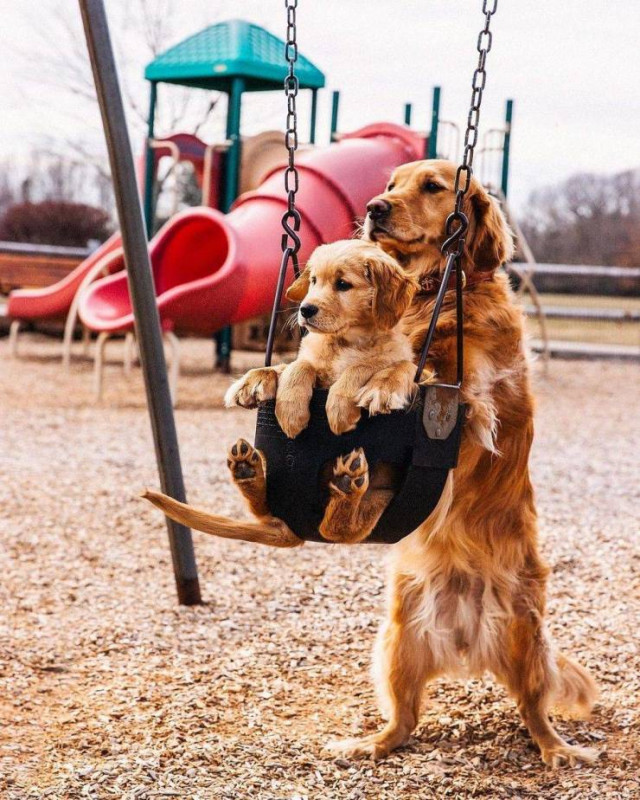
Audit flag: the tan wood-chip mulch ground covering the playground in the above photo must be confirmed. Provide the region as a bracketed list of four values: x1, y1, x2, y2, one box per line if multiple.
[0, 336, 640, 800]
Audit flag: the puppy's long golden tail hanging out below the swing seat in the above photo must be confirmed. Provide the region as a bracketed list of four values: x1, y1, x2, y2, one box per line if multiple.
[140, 489, 303, 547]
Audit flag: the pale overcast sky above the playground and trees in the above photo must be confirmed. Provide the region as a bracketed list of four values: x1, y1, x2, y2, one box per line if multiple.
[0, 0, 640, 207]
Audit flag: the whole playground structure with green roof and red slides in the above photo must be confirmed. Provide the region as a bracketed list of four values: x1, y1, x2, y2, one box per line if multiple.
[8, 20, 520, 398]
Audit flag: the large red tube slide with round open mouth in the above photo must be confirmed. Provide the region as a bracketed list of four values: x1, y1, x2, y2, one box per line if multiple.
[79, 123, 424, 334]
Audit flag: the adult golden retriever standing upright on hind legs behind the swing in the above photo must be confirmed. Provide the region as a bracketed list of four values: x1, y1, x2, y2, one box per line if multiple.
[142, 160, 597, 767]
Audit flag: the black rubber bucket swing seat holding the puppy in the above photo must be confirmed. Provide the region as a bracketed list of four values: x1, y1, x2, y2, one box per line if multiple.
[255, 385, 465, 544]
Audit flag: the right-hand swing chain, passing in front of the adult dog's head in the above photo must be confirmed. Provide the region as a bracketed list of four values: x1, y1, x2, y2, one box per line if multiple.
[442, 0, 498, 256]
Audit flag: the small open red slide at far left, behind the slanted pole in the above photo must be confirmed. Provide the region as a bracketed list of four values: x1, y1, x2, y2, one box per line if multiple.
[7, 233, 122, 320]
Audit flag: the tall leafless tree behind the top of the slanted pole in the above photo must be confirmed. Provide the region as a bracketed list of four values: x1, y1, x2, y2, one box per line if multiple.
[20, 0, 225, 208]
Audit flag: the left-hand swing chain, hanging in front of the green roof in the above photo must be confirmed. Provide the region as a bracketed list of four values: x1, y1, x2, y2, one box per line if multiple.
[282, 0, 301, 278]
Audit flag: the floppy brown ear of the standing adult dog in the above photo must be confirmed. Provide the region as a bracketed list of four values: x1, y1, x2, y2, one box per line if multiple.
[464, 183, 514, 274]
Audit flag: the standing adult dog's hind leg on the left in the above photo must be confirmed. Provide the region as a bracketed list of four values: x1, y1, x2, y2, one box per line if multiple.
[328, 575, 439, 759]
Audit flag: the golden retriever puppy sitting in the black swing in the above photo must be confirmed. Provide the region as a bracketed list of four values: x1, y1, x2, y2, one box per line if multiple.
[144, 240, 418, 547]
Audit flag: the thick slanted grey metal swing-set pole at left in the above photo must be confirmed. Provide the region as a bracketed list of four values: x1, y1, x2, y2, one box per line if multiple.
[79, 0, 201, 605]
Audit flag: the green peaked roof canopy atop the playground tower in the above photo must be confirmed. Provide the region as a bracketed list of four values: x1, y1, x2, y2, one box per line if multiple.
[144, 19, 324, 92]
